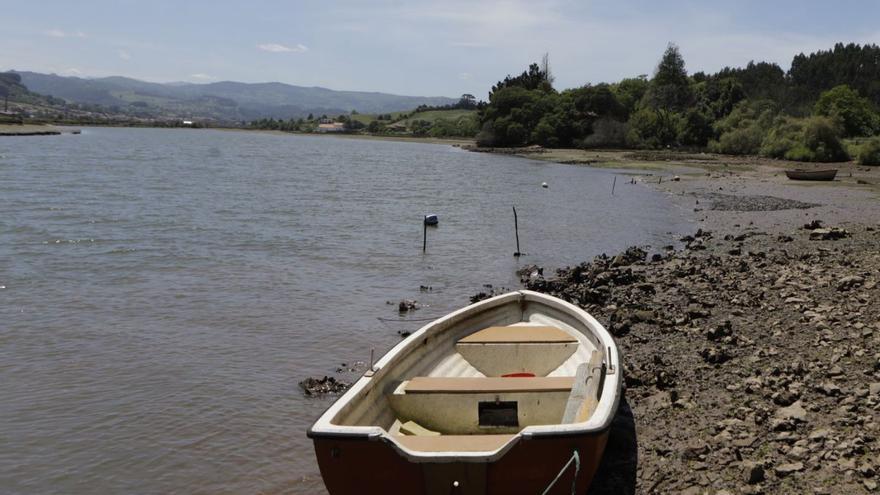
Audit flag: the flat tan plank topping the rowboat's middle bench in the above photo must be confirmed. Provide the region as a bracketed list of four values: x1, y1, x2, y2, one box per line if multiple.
[404, 376, 574, 394]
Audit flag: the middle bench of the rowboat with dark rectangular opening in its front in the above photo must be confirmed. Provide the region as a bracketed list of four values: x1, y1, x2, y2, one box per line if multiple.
[387, 376, 575, 435]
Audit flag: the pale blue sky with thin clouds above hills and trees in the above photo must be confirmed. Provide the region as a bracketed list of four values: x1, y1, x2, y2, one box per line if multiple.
[0, 0, 880, 98]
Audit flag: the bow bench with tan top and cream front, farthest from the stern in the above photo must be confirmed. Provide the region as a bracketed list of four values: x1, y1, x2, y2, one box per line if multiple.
[455, 325, 579, 376]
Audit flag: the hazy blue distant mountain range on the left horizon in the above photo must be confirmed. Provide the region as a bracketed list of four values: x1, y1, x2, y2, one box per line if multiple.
[16, 72, 458, 121]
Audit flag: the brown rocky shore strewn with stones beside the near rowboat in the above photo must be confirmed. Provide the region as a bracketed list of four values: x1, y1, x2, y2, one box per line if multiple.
[523, 223, 880, 494]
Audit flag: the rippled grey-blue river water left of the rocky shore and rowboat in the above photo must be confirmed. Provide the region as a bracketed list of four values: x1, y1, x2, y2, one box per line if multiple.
[0, 129, 690, 494]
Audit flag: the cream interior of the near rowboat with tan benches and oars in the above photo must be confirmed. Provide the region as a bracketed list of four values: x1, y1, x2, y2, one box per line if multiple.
[331, 293, 610, 452]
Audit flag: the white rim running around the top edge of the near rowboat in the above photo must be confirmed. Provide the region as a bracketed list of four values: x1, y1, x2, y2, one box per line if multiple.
[306, 290, 622, 462]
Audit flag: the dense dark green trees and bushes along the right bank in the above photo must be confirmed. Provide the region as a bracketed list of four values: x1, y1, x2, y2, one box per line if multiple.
[477, 44, 880, 162]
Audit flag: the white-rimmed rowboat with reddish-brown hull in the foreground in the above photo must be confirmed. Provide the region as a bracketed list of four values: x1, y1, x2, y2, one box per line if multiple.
[308, 290, 622, 495]
